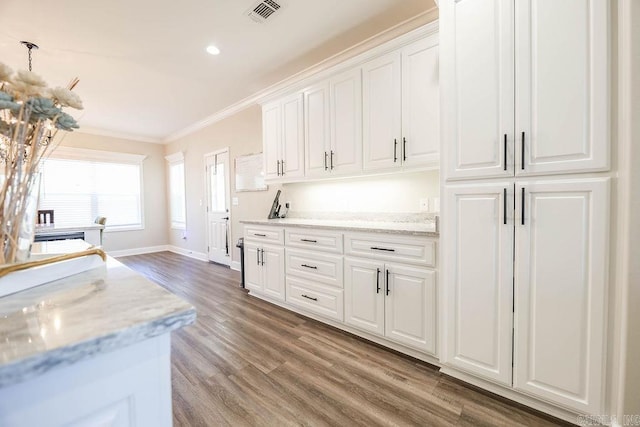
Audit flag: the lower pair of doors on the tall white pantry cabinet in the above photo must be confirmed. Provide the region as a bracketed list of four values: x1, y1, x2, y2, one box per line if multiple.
[442, 178, 609, 414]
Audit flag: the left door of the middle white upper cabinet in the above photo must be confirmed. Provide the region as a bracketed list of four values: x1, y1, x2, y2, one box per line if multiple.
[304, 83, 330, 177]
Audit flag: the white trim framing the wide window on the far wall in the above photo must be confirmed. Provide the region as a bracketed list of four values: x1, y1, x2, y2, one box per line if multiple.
[49, 146, 148, 233]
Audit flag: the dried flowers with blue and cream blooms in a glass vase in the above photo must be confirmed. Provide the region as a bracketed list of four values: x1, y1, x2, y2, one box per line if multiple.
[0, 63, 82, 265]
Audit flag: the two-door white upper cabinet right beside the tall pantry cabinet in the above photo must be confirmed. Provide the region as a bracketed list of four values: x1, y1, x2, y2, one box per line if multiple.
[362, 36, 440, 171]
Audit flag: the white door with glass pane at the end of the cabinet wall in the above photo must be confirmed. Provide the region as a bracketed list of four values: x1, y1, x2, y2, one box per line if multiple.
[205, 150, 231, 265]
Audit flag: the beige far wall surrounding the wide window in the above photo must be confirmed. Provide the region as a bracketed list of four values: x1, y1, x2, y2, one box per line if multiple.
[55, 132, 169, 252]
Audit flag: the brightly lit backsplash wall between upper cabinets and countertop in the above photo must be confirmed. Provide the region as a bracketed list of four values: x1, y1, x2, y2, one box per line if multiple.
[280, 171, 440, 213]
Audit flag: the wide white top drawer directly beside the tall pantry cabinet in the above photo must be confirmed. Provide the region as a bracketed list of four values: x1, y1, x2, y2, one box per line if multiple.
[344, 234, 436, 267]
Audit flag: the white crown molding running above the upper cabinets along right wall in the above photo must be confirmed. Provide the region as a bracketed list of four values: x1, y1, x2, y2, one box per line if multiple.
[161, 7, 438, 144]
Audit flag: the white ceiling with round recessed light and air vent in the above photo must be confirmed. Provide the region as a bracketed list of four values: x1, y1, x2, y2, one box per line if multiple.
[0, 0, 434, 142]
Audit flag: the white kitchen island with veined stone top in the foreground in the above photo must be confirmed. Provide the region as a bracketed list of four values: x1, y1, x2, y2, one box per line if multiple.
[0, 251, 196, 426]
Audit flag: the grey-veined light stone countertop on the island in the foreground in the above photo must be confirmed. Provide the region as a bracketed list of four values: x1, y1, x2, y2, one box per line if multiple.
[0, 257, 196, 387]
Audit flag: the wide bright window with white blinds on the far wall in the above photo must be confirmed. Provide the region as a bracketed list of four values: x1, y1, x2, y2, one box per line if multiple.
[39, 147, 144, 230]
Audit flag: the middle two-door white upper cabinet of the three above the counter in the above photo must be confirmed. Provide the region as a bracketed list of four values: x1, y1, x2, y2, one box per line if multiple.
[304, 68, 362, 177]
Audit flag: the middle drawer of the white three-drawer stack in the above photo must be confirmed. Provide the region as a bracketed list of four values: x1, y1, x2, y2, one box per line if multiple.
[285, 248, 343, 288]
